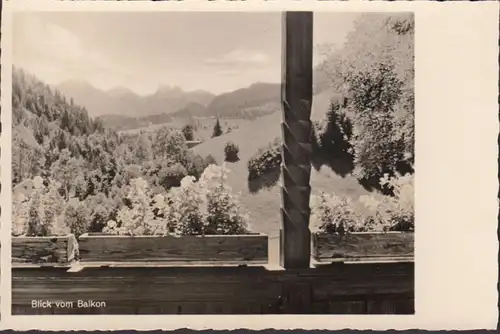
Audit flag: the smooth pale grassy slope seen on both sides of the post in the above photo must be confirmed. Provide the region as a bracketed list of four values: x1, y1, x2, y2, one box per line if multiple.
[193, 90, 378, 235]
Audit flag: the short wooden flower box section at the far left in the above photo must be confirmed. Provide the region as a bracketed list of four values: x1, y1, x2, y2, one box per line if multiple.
[12, 235, 78, 265]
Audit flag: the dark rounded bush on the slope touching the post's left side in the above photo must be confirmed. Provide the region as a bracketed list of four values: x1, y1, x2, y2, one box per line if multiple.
[247, 138, 281, 180]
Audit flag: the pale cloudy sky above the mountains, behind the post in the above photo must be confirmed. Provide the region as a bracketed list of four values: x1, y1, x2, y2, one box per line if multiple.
[13, 12, 357, 94]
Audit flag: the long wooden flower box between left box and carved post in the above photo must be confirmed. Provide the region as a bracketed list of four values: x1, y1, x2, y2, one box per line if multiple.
[78, 234, 268, 264]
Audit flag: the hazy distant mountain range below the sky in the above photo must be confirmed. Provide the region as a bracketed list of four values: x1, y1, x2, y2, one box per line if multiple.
[55, 67, 334, 130]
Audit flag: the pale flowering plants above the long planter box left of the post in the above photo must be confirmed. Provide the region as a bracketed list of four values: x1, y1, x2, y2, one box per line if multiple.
[103, 165, 248, 236]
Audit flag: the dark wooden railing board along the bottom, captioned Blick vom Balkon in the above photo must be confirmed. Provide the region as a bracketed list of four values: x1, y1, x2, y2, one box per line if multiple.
[12, 263, 414, 315]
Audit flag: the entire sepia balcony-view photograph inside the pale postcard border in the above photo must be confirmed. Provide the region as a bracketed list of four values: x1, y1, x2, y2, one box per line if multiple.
[8, 7, 416, 315]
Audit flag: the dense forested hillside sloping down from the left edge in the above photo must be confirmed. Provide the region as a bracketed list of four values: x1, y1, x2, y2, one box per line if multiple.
[12, 68, 217, 234]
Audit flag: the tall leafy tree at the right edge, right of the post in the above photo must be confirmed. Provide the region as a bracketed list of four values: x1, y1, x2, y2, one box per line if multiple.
[323, 14, 415, 183]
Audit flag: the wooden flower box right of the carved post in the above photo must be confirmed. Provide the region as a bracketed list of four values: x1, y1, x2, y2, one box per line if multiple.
[312, 232, 415, 262]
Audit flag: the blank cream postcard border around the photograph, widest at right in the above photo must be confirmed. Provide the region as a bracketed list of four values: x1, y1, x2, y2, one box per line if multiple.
[1, 0, 499, 330]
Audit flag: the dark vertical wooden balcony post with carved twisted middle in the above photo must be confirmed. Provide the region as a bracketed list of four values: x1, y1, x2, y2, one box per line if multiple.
[280, 12, 313, 268]
